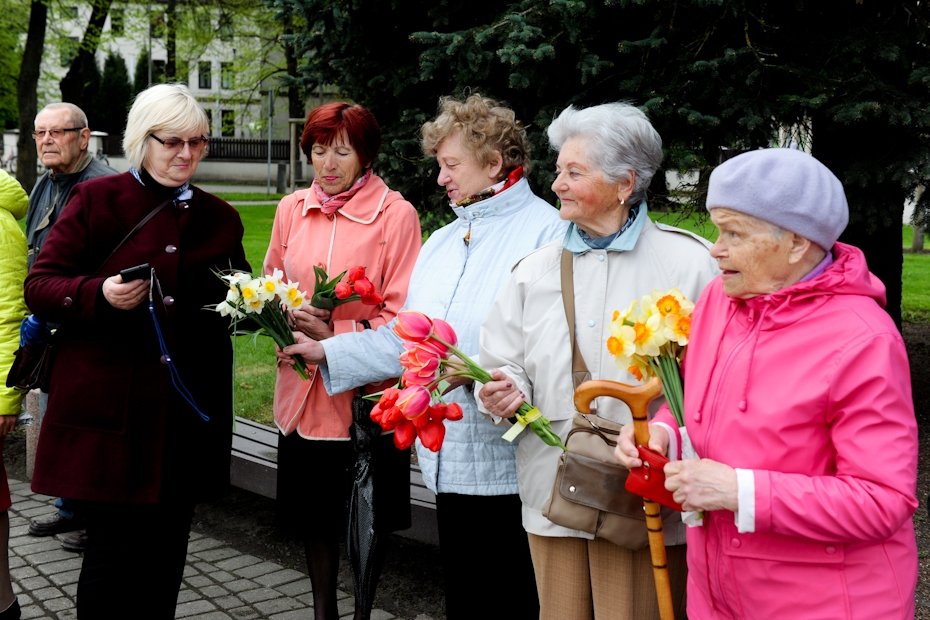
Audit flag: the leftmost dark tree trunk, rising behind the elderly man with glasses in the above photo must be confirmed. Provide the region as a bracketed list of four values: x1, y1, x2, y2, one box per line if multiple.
[16, 0, 48, 191]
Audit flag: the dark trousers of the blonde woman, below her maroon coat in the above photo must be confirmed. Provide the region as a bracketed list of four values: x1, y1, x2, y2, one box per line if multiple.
[77, 502, 194, 620]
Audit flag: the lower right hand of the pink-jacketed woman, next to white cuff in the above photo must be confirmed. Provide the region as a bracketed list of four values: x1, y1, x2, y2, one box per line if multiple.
[665, 459, 739, 512]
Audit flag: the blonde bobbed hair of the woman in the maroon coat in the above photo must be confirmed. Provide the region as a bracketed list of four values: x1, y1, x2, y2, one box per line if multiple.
[123, 84, 209, 170]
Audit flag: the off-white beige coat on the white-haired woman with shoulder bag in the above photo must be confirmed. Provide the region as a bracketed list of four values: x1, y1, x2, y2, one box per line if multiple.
[479, 214, 719, 544]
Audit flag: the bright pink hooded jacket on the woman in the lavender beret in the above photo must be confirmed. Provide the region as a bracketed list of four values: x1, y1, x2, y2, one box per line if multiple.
[659, 243, 918, 620]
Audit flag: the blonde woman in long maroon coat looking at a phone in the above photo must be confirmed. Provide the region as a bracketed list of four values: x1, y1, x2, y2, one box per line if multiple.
[26, 84, 249, 620]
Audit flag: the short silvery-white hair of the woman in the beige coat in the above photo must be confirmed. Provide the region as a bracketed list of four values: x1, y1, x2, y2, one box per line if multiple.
[548, 103, 662, 204]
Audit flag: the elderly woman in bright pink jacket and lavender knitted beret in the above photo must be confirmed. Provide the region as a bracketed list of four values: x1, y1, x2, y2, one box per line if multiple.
[616, 149, 917, 620]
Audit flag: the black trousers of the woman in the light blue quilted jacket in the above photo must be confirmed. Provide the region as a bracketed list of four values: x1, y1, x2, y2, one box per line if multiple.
[436, 493, 539, 620]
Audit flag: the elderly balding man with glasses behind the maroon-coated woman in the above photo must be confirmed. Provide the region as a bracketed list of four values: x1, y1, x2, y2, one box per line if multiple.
[26, 103, 117, 552]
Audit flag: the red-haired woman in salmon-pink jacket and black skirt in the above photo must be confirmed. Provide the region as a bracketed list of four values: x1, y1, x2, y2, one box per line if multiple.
[264, 103, 421, 620]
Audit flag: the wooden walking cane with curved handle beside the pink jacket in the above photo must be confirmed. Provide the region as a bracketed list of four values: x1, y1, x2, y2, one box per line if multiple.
[575, 377, 675, 620]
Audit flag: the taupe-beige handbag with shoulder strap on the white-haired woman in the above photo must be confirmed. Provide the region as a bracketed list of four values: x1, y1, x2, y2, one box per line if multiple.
[543, 250, 671, 551]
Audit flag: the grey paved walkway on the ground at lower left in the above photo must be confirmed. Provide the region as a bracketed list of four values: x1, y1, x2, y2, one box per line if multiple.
[9, 479, 406, 620]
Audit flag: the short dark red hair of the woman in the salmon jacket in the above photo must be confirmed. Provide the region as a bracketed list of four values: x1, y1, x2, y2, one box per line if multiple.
[300, 101, 381, 168]
